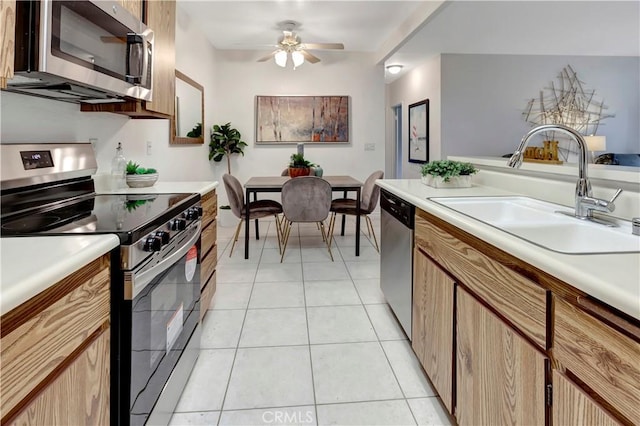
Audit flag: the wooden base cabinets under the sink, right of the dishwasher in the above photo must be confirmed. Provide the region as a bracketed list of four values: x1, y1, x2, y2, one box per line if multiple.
[412, 210, 640, 426]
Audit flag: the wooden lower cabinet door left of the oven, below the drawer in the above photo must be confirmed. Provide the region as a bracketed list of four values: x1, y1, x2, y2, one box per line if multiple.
[10, 328, 110, 425]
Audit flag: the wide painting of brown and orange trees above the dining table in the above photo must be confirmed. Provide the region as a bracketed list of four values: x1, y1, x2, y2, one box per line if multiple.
[256, 96, 350, 144]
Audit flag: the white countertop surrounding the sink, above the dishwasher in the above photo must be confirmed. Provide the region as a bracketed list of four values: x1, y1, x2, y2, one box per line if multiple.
[377, 179, 640, 319]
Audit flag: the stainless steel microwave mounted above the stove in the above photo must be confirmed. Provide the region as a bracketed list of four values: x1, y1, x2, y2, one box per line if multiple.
[6, 0, 153, 103]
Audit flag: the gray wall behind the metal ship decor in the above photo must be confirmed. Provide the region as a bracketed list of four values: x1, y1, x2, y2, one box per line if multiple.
[440, 54, 640, 158]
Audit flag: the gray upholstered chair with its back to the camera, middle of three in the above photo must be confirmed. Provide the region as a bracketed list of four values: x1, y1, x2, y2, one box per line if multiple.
[280, 176, 333, 262]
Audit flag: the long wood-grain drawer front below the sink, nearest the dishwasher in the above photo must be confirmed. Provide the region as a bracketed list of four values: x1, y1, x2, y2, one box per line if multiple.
[415, 215, 547, 349]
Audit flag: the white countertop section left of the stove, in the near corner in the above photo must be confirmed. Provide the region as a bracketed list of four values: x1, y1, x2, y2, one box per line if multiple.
[0, 235, 120, 315]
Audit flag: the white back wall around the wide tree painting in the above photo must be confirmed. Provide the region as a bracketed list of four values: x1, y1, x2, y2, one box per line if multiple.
[208, 51, 385, 202]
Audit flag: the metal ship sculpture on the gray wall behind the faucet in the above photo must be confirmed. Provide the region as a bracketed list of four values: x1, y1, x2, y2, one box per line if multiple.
[522, 65, 615, 164]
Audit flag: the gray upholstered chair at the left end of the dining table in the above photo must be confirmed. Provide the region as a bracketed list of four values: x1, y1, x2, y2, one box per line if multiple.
[222, 173, 282, 257]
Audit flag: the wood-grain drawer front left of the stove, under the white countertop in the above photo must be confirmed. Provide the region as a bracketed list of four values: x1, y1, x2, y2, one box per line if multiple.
[0, 256, 110, 418]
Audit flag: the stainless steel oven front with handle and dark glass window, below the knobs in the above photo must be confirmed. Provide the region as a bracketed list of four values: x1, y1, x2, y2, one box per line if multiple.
[119, 223, 200, 425]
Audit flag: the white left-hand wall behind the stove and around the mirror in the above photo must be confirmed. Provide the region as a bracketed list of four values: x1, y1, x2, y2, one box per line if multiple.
[0, 7, 217, 181]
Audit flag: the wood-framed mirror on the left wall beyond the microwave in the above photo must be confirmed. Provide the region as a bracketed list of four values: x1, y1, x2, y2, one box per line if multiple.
[171, 70, 204, 144]
